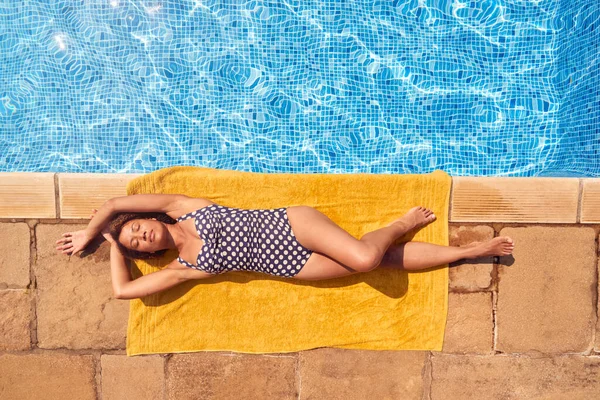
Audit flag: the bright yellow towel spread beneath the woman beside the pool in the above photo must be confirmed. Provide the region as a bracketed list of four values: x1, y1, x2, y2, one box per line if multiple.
[127, 167, 451, 356]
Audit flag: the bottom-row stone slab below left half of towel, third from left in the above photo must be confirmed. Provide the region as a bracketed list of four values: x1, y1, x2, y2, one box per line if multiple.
[166, 352, 299, 400]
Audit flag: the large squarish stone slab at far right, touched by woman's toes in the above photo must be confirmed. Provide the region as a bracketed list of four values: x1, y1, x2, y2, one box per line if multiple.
[496, 226, 597, 353]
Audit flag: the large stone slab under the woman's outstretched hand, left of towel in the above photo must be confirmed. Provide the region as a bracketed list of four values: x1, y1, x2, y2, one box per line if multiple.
[34, 224, 129, 349]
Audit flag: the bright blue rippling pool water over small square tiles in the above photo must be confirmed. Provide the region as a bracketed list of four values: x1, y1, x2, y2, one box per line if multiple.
[0, 0, 600, 176]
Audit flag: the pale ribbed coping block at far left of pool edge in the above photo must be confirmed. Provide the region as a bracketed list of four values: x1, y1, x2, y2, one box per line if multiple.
[0, 172, 57, 218]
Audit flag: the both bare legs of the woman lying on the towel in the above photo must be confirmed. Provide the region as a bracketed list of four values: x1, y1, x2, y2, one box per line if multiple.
[288, 206, 514, 280]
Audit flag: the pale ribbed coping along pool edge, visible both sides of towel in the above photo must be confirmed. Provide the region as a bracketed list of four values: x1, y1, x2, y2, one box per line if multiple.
[0, 172, 600, 224]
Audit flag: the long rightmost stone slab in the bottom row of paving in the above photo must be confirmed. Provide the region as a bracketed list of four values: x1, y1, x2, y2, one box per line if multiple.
[430, 353, 600, 400]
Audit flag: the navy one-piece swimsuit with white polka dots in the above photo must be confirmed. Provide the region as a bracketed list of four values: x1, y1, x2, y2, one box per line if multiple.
[177, 204, 312, 277]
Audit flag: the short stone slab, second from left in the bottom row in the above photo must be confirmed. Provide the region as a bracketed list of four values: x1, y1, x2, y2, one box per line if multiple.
[100, 354, 165, 400]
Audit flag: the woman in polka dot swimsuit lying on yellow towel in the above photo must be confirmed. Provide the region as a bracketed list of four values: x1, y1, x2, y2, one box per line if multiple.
[56, 194, 514, 299]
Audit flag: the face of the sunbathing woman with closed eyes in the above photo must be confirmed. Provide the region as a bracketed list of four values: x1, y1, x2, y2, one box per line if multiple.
[119, 218, 167, 253]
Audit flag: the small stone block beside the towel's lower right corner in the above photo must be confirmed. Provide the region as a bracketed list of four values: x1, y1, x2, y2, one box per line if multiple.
[443, 292, 494, 354]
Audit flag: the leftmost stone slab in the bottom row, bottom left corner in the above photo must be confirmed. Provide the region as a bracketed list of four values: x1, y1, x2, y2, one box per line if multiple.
[0, 352, 96, 400]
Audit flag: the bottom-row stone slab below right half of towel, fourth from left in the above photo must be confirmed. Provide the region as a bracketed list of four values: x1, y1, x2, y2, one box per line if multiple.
[298, 348, 429, 400]
